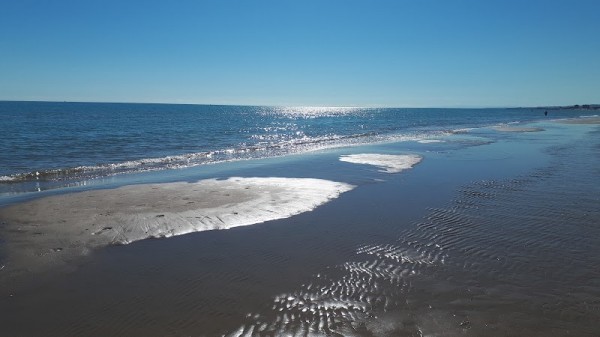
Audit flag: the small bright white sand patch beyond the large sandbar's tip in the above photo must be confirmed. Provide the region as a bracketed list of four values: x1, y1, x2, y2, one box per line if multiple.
[340, 153, 423, 173]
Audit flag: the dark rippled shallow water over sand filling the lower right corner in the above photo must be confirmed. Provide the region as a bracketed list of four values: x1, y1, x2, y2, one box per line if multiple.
[225, 131, 600, 336]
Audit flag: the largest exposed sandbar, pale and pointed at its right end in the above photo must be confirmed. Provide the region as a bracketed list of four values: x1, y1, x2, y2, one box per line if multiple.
[0, 178, 354, 268]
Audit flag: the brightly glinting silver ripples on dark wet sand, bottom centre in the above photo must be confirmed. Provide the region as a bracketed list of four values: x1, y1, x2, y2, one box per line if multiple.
[225, 241, 444, 337]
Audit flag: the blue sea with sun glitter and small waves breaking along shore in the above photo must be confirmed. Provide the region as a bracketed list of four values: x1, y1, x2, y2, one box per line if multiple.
[0, 102, 589, 194]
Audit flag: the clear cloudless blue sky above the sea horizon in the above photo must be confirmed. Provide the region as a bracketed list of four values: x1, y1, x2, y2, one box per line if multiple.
[0, 0, 600, 107]
